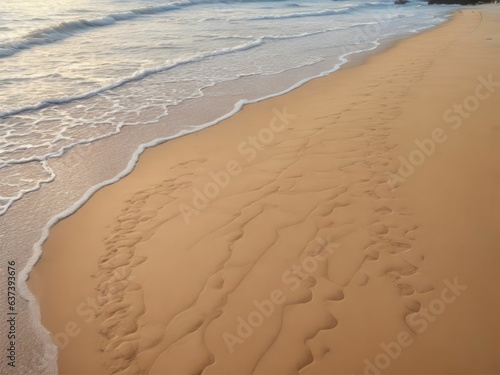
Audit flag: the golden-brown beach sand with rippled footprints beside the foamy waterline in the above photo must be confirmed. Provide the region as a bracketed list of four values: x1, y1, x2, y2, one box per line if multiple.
[30, 7, 500, 374]
